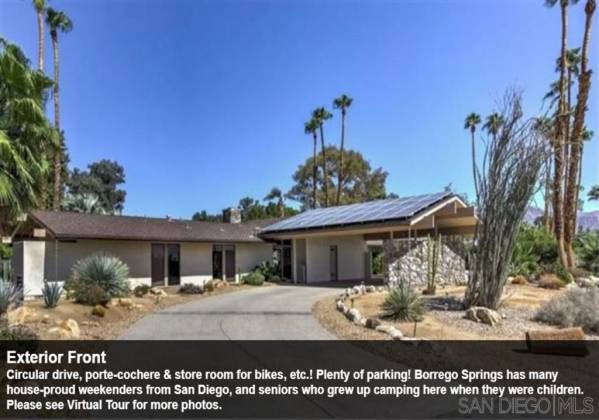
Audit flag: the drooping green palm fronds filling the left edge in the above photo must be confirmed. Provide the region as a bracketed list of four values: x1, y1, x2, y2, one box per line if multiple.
[0, 38, 57, 234]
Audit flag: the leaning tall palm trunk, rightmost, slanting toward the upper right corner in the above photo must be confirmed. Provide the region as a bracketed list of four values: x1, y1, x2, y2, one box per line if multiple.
[564, 0, 595, 267]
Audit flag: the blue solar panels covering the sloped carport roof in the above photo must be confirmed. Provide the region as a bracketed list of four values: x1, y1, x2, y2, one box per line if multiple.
[262, 192, 452, 233]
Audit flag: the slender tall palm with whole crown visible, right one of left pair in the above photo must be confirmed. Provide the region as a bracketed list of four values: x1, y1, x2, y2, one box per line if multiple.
[46, 8, 73, 210]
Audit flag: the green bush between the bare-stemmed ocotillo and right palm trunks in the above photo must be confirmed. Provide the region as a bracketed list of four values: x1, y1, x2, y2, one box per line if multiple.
[510, 223, 558, 277]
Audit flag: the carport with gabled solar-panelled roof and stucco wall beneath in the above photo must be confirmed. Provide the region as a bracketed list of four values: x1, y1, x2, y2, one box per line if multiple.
[260, 192, 476, 283]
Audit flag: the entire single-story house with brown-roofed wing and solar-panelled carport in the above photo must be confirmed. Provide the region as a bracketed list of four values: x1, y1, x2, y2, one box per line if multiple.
[13, 192, 476, 295]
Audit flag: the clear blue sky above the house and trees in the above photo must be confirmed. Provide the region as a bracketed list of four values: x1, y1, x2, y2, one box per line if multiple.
[0, 0, 599, 217]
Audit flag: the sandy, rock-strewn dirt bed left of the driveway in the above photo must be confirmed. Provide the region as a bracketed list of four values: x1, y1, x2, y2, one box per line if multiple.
[13, 284, 253, 340]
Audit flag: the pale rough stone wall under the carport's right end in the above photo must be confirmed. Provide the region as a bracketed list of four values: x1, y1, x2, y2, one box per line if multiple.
[383, 238, 468, 287]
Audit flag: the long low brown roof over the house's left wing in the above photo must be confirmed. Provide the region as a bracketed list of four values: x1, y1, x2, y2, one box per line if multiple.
[30, 211, 272, 242]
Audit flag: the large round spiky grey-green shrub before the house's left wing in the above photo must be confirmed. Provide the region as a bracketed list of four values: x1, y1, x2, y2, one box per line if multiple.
[67, 254, 129, 305]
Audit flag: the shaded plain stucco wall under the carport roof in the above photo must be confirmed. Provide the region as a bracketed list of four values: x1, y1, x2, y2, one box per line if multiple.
[306, 235, 366, 283]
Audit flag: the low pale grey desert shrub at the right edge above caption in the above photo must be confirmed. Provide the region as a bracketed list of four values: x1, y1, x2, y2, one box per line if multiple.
[535, 287, 599, 332]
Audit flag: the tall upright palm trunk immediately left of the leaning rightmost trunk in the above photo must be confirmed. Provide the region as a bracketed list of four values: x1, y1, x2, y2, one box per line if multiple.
[553, 0, 568, 267]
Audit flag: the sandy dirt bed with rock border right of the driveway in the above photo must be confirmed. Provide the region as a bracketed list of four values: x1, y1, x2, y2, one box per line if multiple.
[313, 284, 596, 340]
